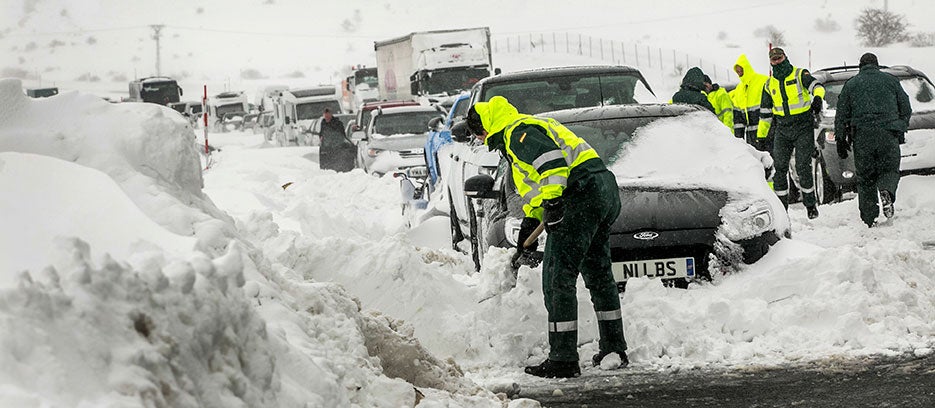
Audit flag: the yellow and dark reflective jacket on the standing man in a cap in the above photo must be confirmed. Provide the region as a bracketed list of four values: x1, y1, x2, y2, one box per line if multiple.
[756, 67, 825, 139]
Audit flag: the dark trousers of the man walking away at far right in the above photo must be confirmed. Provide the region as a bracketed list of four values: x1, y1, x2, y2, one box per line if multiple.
[853, 128, 900, 225]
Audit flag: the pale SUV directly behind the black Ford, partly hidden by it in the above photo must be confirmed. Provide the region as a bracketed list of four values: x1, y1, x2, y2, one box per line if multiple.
[442, 65, 657, 270]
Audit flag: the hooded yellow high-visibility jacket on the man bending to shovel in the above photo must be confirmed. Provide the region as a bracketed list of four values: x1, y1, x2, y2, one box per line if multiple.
[474, 96, 604, 220]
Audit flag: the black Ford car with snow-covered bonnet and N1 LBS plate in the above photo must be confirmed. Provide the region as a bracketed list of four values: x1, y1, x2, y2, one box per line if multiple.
[465, 104, 791, 290]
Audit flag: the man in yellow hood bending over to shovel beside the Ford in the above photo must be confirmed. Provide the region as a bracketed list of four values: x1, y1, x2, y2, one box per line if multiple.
[467, 96, 629, 378]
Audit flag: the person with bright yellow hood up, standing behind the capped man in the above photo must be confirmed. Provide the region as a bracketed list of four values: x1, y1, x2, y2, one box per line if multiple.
[729, 54, 772, 152]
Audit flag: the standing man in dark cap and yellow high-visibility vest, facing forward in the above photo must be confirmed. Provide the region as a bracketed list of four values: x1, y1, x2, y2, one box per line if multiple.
[756, 48, 825, 219]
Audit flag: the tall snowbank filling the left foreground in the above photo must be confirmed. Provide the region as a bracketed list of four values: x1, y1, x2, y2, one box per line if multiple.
[0, 80, 523, 407]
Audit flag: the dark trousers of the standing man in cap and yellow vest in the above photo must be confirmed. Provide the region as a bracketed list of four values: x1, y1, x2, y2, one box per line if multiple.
[772, 116, 816, 207]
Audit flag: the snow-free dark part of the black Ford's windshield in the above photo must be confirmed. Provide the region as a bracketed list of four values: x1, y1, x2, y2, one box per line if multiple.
[565, 116, 672, 166]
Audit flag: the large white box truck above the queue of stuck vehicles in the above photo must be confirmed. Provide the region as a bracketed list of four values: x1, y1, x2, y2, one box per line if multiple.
[373, 27, 492, 101]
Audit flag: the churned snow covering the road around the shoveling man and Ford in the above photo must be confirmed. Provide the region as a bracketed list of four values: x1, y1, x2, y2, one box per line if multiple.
[205, 129, 935, 386]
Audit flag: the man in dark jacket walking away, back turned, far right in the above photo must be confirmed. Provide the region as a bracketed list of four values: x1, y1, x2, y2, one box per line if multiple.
[834, 52, 912, 227]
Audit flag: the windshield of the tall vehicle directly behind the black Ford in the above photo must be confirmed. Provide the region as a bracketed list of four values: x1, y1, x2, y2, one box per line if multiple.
[481, 74, 656, 115]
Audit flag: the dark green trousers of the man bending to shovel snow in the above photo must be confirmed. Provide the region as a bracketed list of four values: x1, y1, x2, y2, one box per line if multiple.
[542, 170, 627, 361]
